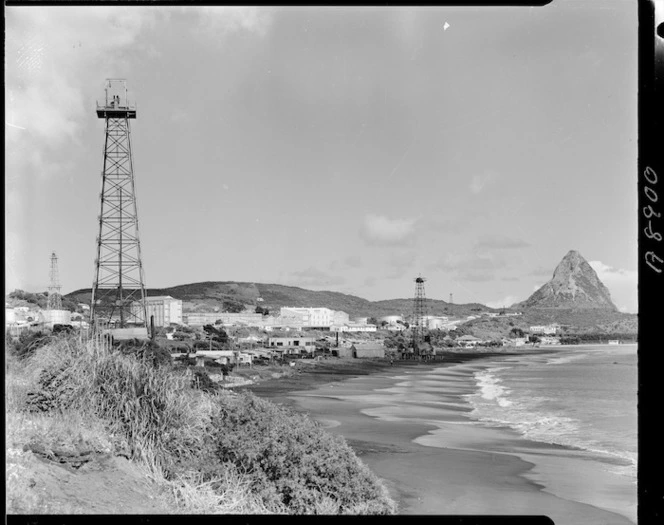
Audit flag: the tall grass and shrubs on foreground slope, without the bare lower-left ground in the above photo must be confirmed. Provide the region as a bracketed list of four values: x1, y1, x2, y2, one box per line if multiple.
[5, 337, 394, 514]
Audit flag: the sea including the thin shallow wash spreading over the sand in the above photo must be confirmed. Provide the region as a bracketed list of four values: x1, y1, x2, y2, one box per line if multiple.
[290, 344, 638, 524]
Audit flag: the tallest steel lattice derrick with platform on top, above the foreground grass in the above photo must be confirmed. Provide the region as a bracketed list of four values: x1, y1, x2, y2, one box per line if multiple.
[90, 79, 147, 328]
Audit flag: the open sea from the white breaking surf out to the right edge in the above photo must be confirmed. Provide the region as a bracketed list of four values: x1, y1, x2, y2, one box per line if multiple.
[467, 345, 637, 474]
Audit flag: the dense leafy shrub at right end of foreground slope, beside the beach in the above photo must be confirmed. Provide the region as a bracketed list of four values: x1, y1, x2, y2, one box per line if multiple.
[213, 393, 395, 514]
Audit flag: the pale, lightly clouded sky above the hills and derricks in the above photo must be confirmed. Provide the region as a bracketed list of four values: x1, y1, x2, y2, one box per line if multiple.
[5, 0, 637, 312]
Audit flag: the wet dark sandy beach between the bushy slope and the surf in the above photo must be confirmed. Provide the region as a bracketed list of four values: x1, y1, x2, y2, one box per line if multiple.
[243, 355, 636, 525]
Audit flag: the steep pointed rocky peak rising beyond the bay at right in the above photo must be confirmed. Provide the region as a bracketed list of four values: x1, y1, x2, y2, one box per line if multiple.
[519, 250, 617, 311]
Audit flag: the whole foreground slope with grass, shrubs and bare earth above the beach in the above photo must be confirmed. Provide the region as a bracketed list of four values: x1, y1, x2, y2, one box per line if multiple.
[5, 337, 396, 514]
